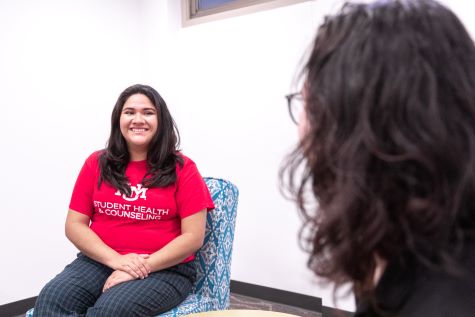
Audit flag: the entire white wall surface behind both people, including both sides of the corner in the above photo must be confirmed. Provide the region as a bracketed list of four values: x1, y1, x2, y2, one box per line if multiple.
[0, 0, 475, 310]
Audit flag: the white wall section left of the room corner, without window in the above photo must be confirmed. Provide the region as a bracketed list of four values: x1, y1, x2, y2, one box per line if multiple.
[0, 0, 144, 305]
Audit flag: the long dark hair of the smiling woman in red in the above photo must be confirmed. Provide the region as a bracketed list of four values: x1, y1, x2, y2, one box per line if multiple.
[98, 85, 183, 195]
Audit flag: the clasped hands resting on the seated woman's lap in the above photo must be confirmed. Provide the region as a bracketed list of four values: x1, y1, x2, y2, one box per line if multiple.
[102, 253, 151, 292]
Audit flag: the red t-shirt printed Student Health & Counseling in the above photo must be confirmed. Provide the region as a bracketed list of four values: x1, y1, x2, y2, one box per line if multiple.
[69, 152, 214, 262]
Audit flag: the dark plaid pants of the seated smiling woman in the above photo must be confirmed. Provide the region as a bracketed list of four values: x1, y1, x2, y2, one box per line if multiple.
[33, 253, 196, 317]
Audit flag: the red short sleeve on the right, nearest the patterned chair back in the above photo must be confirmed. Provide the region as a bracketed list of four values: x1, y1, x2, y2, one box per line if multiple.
[175, 157, 214, 218]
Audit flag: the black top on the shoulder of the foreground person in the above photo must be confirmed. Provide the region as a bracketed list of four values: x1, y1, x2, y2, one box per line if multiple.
[355, 241, 475, 317]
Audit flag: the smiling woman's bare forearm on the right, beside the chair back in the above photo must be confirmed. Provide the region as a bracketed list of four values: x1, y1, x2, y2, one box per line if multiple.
[146, 209, 207, 271]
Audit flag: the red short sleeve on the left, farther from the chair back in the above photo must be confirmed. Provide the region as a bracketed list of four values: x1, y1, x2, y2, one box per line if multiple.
[69, 152, 99, 217]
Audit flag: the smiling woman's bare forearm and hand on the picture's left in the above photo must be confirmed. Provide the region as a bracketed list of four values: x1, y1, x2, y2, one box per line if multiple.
[65, 209, 150, 278]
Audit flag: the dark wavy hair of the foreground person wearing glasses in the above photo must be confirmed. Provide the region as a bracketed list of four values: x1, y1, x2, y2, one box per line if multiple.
[281, 0, 475, 294]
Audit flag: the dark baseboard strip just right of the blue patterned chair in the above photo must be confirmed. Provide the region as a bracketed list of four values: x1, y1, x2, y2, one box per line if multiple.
[231, 280, 322, 313]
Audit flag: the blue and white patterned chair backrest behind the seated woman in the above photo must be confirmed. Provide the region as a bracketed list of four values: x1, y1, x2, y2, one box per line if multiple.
[193, 177, 239, 309]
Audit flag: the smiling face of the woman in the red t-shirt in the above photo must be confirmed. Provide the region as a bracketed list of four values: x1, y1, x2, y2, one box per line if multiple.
[120, 93, 158, 154]
